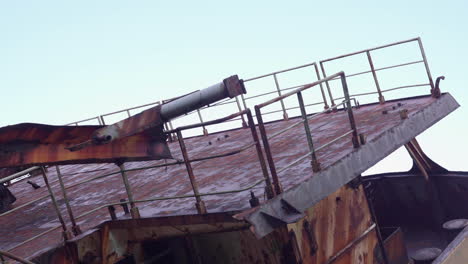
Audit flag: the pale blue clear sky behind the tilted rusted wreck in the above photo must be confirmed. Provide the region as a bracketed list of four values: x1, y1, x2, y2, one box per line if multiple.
[0, 0, 468, 171]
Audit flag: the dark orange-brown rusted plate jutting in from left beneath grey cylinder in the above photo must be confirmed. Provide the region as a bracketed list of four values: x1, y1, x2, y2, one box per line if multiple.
[0, 123, 171, 167]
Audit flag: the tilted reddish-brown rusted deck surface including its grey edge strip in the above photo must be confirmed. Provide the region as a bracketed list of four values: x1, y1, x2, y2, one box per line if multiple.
[0, 94, 458, 257]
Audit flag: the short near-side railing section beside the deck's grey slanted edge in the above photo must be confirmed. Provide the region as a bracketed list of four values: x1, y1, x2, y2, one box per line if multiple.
[255, 72, 363, 194]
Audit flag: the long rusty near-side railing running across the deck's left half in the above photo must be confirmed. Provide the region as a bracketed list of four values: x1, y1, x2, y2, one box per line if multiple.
[0, 109, 274, 255]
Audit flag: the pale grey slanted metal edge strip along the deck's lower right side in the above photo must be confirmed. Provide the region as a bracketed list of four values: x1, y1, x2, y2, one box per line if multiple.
[244, 93, 459, 238]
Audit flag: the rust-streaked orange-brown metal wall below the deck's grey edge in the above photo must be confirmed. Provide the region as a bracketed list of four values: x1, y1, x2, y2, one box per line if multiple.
[287, 186, 381, 264]
